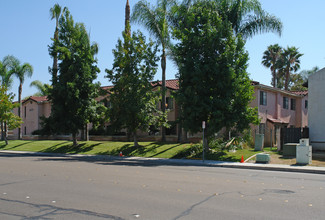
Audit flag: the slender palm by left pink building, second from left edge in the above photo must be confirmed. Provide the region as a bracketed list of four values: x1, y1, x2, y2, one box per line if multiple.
[8, 56, 33, 139]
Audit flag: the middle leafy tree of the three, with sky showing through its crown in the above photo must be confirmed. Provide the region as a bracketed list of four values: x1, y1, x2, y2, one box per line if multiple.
[106, 25, 166, 146]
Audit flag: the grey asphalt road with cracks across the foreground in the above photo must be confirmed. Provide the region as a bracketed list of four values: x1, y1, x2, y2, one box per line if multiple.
[0, 153, 325, 220]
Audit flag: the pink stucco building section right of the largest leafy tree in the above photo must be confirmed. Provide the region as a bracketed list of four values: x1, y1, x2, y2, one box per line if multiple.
[251, 81, 308, 148]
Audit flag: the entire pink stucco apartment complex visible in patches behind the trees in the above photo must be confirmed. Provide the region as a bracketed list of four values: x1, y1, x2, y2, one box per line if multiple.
[13, 79, 308, 146]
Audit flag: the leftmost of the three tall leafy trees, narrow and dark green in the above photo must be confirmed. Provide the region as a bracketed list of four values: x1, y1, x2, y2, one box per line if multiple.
[49, 9, 99, 146]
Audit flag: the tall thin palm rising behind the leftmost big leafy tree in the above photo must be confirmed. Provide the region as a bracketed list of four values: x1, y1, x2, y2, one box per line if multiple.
[50, 4, 66, 85]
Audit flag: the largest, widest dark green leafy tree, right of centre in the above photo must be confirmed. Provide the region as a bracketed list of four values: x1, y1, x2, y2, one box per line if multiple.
[174, 1, 257, 148]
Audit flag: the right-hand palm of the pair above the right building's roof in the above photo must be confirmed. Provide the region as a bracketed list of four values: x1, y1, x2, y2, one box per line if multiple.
[280, 47, 303, 90]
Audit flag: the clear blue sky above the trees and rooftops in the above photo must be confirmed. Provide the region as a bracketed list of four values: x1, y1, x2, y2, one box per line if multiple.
[0, 0, 325, 99]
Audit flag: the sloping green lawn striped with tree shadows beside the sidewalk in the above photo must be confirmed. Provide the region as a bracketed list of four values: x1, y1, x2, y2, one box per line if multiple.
[0, 140, 268, 161]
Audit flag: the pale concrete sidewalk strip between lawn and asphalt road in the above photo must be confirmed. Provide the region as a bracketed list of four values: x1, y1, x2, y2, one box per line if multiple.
[0, 151, 325, 174]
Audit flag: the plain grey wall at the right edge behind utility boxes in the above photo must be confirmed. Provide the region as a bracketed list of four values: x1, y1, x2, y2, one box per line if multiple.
[308, 68, 325, 150]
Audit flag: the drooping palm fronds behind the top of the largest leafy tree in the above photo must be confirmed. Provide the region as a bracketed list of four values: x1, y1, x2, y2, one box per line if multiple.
[178, 0, 283, 39]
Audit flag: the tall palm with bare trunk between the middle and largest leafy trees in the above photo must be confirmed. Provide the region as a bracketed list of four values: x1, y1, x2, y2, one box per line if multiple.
[131, 0, 176, 141]
